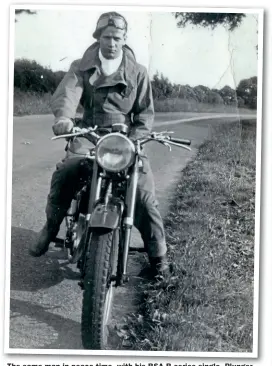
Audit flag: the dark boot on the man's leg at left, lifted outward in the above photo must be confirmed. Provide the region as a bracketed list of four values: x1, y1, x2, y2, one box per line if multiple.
[28, 207, 65, 257]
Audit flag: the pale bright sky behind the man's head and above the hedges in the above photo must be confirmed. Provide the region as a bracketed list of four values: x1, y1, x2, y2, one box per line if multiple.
[14, 6, 258, 89]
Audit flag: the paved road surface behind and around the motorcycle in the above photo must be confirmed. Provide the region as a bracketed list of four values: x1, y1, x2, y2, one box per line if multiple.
[9, 114, 255, 351]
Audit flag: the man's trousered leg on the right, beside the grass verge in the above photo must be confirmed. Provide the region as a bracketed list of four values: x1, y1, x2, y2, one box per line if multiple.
[135, 159, 169, 275]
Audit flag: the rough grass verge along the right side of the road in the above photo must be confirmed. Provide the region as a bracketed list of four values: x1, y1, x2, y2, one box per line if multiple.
[124, 121, 256, 352]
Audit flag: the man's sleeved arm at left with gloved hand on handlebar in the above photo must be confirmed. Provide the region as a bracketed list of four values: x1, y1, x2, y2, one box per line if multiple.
[50, 60, 83, 135]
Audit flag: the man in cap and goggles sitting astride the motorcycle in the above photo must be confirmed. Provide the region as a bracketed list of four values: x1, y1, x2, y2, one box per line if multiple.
[29, 12, 168, 276]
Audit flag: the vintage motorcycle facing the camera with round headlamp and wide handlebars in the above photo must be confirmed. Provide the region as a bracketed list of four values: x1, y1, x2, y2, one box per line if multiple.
[52, 124, 191, 349]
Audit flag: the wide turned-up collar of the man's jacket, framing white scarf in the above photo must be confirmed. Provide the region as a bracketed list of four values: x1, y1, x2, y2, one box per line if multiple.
[79, 42, 137, 91]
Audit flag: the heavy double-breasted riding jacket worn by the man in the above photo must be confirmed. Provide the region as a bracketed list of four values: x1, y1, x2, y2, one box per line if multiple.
[51, 42, 154, 139]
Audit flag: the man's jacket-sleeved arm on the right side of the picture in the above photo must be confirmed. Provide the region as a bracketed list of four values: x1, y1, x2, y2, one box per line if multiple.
[129, 68, 154, 139]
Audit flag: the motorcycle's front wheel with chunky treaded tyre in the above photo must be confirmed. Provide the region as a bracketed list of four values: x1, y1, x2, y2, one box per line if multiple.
[81, 229, 119, 349]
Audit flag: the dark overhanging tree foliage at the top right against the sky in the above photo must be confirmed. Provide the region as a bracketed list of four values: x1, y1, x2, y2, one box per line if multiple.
[174, 13, 245, 31]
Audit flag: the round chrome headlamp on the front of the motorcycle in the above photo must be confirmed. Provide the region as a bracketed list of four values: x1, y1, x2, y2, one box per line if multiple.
[95, 133, 135, 173]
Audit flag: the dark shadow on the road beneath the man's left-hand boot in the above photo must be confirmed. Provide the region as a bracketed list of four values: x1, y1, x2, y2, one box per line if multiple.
[10, 227, 79, 292]
